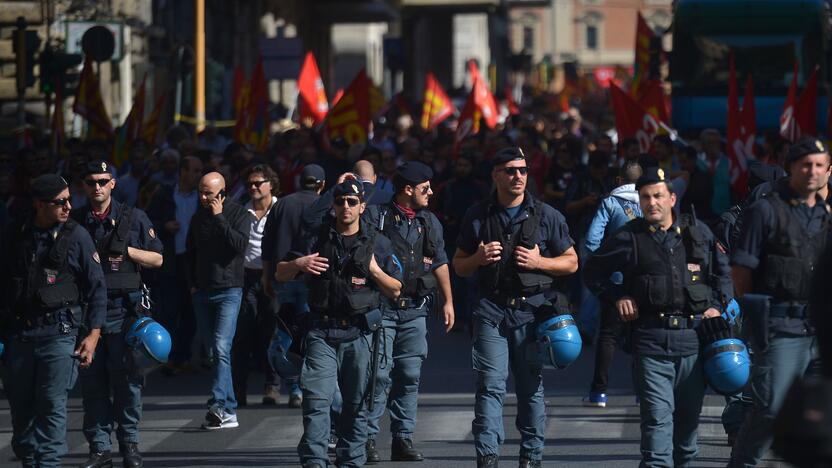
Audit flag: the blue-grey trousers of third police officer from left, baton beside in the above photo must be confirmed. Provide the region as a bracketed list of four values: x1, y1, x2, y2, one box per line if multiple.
[298, 329, 370, 467]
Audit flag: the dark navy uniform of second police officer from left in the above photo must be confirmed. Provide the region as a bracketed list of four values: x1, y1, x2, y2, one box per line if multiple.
[72, 198, 162, 462]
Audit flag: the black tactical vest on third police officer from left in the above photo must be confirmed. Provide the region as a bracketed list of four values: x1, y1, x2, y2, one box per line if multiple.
[309, 222, 381, 317]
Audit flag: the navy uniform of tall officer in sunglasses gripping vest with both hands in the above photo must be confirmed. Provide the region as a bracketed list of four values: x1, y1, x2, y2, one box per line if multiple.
[457, 188, 574, 462]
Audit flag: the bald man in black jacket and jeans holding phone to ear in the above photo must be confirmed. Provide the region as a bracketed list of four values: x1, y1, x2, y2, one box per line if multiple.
[187, 172, 251, 430]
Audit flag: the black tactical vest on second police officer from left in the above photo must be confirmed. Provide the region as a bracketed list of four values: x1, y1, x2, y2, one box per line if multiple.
[78, 205, 142, 298]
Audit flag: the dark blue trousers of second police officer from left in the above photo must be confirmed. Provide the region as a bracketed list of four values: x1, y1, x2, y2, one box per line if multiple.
[80, 326, 144, 452]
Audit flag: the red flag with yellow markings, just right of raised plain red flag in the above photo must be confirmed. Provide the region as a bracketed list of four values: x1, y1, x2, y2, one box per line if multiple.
[326, 69, 384, 144]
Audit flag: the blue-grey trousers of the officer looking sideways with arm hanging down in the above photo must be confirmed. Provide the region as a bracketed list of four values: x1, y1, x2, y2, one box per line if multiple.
[368, 317, 428, 439]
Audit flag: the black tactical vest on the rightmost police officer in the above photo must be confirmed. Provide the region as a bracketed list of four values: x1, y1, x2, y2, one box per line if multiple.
[754, 192, 829, 303]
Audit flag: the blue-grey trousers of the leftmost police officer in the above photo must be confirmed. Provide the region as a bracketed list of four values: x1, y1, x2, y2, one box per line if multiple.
[3, 334, 78, 467]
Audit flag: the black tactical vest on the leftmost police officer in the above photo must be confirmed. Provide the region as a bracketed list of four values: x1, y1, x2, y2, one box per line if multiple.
[8, 219, 80, 318]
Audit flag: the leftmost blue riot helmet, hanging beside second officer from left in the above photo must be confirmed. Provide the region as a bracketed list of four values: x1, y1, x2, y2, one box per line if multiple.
[124, 317, 171, 374]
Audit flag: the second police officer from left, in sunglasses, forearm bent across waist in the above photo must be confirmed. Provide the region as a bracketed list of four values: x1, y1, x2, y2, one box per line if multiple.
[72, 160, 162, 468]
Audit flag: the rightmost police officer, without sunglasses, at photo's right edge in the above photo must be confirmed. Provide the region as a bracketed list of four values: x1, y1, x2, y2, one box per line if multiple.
[731, 138, 830, 467]
